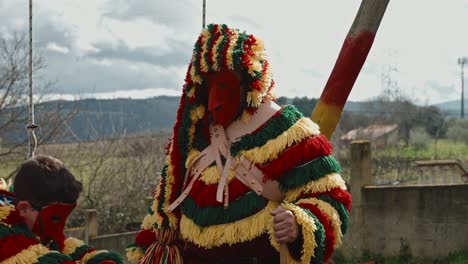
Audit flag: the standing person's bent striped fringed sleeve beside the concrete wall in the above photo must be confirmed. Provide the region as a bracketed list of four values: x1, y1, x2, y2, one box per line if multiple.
[262, 121, 351, 263]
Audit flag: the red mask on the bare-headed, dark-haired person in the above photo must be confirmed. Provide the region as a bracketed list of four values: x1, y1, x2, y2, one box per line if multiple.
[32, 203, 76, 250]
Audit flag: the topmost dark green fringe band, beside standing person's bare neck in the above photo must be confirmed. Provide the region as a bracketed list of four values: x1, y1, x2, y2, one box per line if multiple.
[231, 105, 303, 156]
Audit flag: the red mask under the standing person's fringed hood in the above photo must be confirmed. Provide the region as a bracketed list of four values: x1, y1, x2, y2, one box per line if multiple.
[206, 70, 241, 127]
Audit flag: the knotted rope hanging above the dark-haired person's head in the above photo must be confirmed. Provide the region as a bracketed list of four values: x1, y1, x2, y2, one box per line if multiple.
[26, 0, 38, 158]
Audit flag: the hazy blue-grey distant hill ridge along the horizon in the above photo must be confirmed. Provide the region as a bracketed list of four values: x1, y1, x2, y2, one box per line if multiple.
[0, 96, 460, 143]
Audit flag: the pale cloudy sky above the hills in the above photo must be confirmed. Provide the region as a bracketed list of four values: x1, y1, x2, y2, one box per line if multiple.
[0, 0, 468, 104]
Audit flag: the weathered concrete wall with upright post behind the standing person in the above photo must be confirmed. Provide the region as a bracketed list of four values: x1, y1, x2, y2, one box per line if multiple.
[341, 142, 468, 257]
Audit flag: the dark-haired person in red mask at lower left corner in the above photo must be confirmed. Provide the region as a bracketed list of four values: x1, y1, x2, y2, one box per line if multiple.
[0, 155, 123, 264]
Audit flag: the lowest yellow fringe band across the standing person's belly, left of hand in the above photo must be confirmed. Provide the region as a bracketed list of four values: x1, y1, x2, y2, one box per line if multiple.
[180, 201, 278, 248]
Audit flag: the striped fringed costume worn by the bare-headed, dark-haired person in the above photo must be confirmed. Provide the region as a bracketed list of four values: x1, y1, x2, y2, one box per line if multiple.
[0, 190, 123, 264]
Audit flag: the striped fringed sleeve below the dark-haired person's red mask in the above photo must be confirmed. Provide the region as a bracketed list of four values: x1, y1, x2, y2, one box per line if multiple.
[62, 237, 124, 264]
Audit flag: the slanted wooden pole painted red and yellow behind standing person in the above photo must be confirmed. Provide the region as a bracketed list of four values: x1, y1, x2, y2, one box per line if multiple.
[311, 0, 389, 139]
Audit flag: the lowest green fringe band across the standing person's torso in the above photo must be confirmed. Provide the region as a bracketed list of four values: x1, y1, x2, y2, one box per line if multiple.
[181, 191, 268, 226]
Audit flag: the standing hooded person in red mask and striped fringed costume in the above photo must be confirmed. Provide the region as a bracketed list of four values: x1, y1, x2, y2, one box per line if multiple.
[127, 25, 351, 263]
